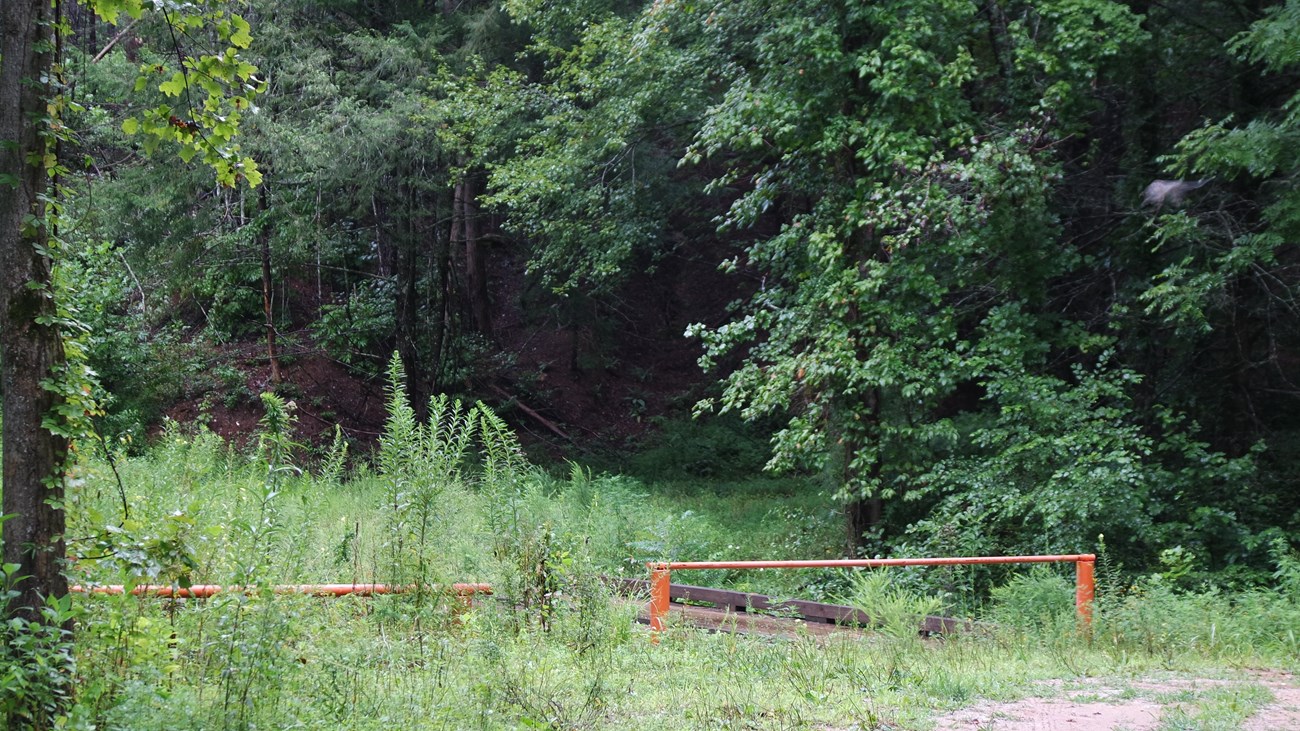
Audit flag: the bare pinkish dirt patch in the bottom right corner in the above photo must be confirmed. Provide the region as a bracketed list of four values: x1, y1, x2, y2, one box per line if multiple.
[935, 672, 1300, 731]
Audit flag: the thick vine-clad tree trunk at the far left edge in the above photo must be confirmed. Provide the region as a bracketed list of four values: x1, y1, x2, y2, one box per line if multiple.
[0, 0, 68, 619]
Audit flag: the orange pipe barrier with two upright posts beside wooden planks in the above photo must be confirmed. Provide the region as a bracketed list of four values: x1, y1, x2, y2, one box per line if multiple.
[647, 553, 1097, 643]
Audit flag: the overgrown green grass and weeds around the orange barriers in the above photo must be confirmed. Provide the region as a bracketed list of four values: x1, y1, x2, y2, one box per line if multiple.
[0, 395, 1300, 730]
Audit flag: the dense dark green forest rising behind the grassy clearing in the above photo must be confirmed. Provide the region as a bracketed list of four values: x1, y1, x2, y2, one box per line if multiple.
[5, 0, 1300, 579]
